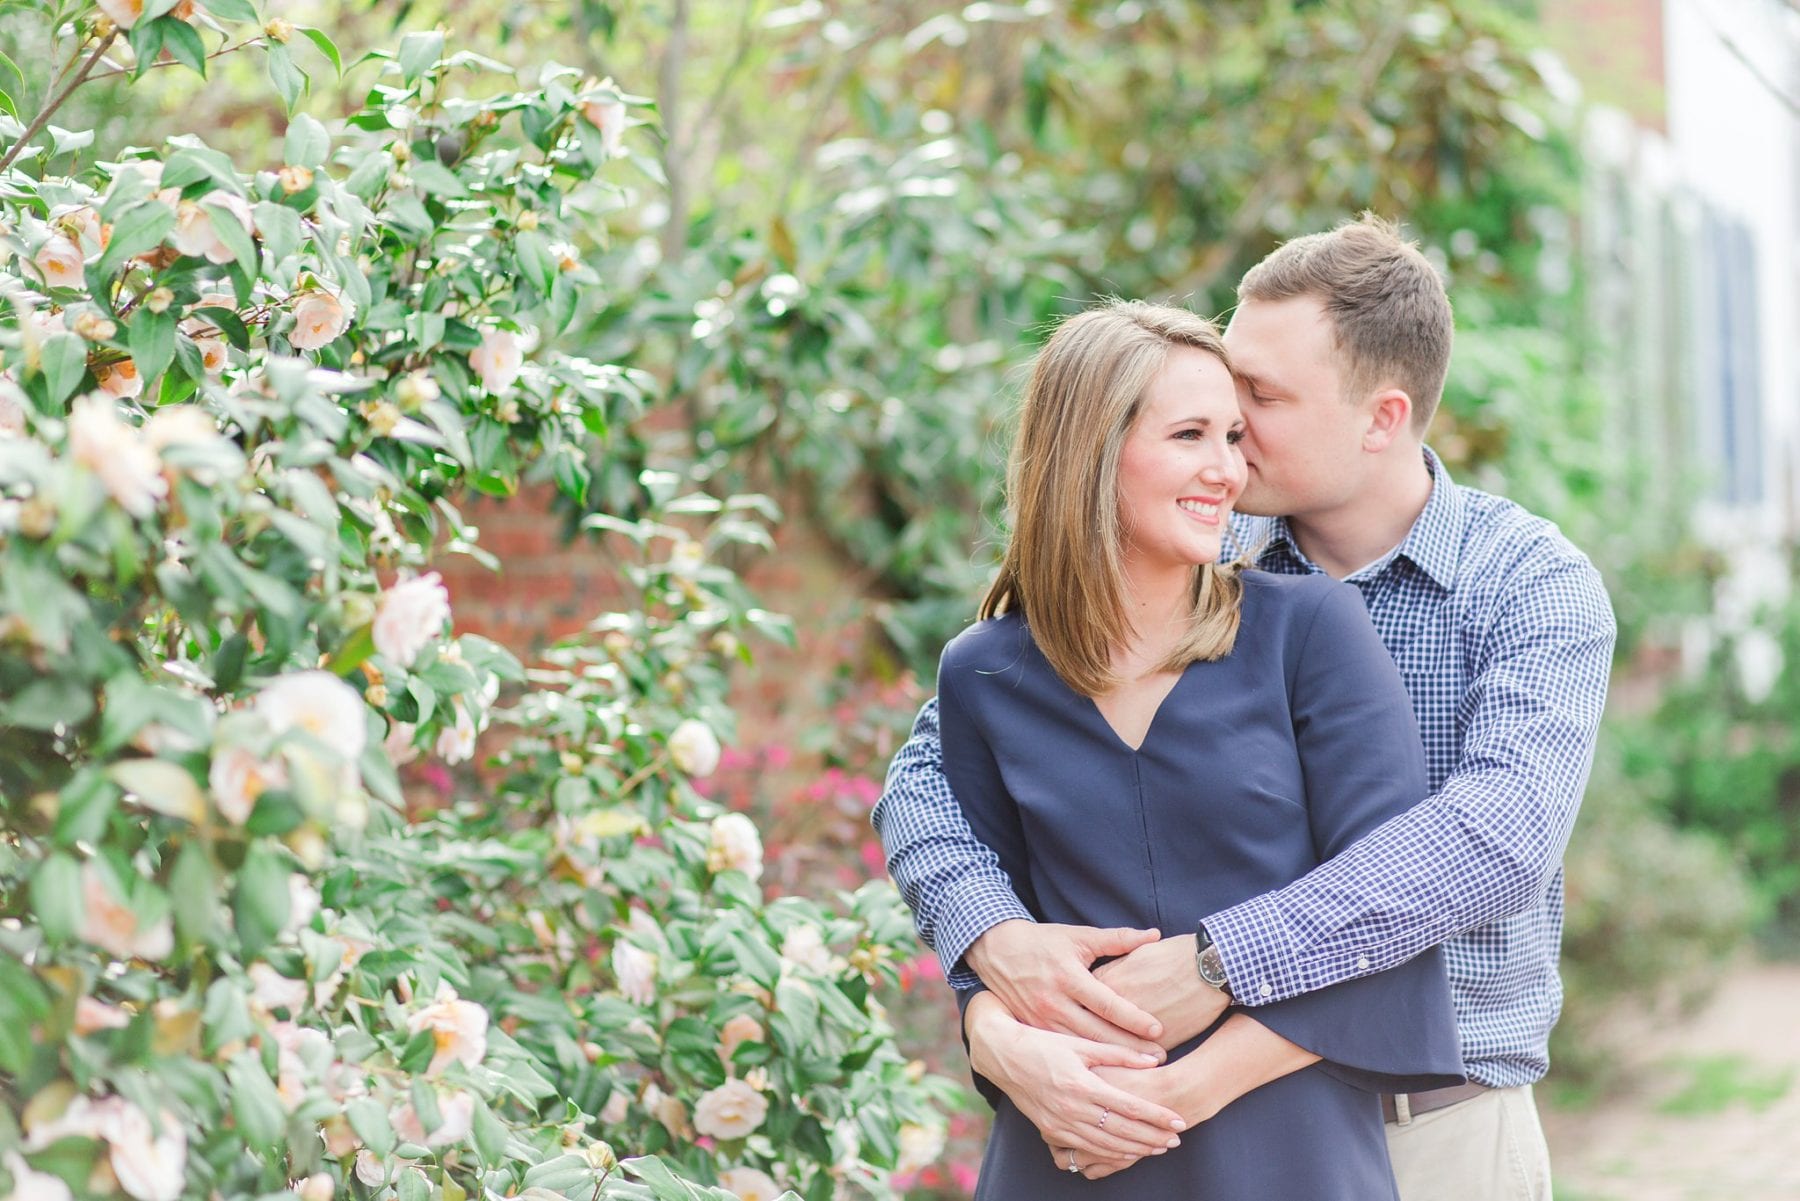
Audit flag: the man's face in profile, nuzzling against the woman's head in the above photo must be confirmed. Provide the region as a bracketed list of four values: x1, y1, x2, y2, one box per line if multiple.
[1226, 295, 1368, 519]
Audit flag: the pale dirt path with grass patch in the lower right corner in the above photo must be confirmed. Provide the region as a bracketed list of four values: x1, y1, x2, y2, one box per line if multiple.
[1541, 963, 1800, 1201]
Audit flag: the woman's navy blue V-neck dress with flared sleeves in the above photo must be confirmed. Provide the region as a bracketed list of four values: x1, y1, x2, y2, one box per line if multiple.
[938, 571, 1462, 1201]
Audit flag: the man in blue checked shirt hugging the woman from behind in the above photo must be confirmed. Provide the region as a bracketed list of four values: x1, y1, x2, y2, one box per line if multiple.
[875, 218, 1615, 1201]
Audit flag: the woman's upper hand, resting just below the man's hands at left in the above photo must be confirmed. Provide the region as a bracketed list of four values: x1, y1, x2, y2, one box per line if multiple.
[965, 992, 1184, 1167]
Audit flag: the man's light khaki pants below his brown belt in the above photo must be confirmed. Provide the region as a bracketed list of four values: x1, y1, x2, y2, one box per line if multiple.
[1388, 1086, 1550, 1201]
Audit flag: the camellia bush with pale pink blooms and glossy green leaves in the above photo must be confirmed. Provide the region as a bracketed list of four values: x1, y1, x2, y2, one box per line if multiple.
[0, 0, 950, 1201]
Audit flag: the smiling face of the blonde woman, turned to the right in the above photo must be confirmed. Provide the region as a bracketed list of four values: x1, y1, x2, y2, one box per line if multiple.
[1120, 346, 1244, 569]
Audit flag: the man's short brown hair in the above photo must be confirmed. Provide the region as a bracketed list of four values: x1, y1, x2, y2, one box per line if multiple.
[1238, 212, 1454, 434]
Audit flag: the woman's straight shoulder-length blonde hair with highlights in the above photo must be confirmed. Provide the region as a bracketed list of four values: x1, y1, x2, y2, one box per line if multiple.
[981, 301, 1244, 697]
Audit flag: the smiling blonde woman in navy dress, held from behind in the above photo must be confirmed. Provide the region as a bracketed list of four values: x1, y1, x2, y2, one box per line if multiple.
[938, 303, 1462, 1201]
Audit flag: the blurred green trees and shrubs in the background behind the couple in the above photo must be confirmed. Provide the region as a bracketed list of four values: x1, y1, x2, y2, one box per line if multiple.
[0, 0, 1800, 1188]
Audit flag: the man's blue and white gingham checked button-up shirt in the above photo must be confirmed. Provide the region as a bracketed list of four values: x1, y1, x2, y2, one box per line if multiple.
[875, 450, 1616, 1088]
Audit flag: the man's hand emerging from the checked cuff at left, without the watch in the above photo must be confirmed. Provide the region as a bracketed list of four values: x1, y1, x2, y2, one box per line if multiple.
[963, 920, 1166, 1061]
